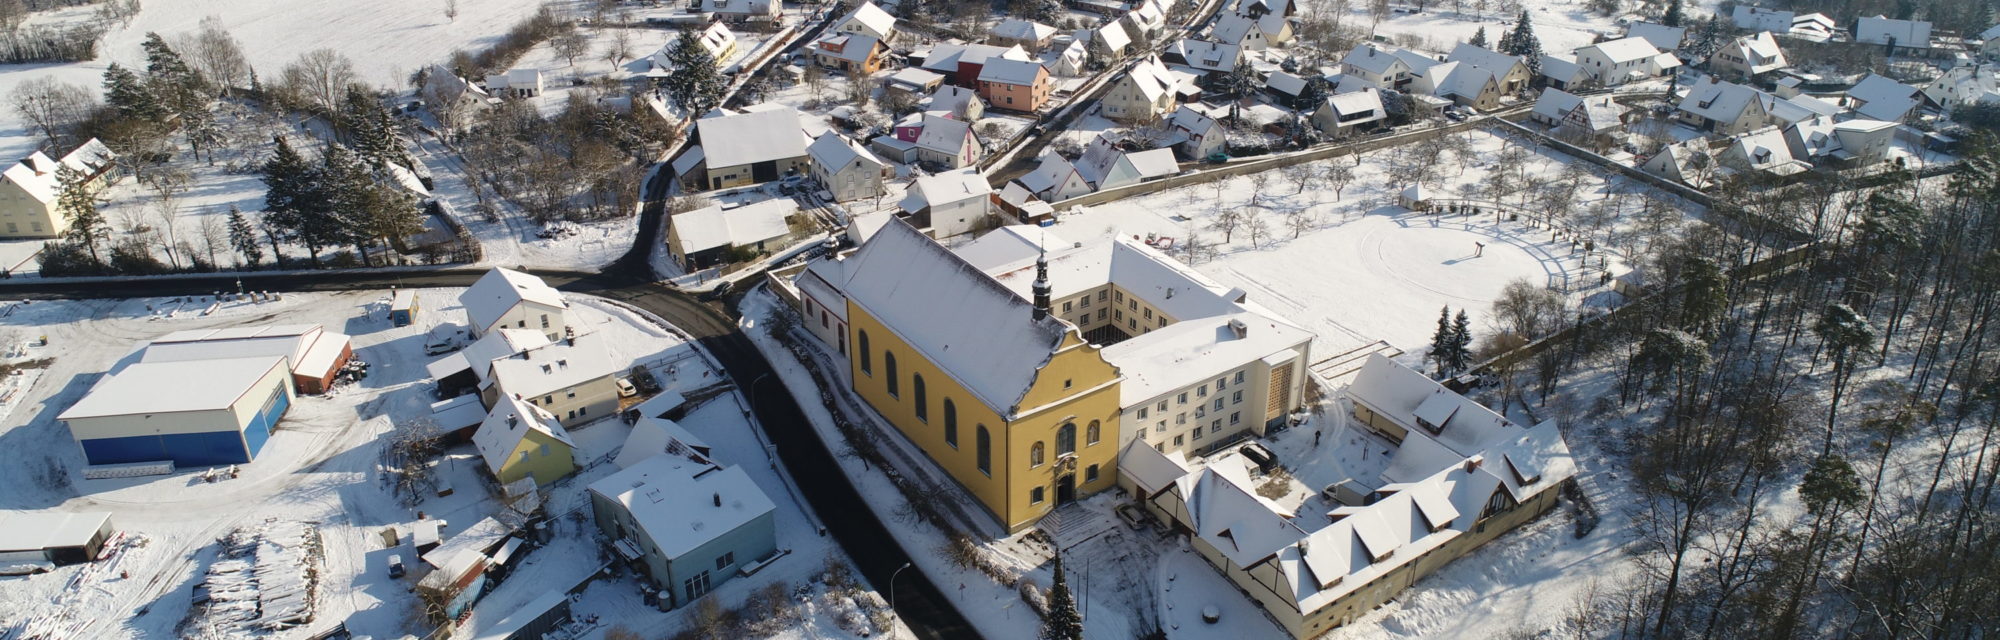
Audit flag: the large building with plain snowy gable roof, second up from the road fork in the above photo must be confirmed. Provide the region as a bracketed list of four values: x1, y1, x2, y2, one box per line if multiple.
[674, 105, 812, 190]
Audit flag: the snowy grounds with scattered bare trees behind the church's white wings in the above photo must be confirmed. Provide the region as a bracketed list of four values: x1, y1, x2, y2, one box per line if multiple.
[1052, 130, 1694, 358]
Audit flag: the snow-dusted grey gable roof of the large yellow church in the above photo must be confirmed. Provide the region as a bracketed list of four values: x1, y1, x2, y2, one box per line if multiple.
[842, 220, 1070, 414]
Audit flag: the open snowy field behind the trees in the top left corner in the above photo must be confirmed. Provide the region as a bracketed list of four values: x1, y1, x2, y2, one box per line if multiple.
[0, 0, 582, 158]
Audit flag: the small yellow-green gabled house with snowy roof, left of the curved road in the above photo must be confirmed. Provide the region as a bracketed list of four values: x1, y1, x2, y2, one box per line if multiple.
[472, 396, 576, 486]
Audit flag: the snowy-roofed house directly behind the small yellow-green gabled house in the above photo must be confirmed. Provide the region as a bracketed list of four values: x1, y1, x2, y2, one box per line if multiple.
[480, 334, 632, 426]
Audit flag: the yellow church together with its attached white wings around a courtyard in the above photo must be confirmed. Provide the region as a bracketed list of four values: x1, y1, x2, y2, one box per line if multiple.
[788, 222, 1312, 530]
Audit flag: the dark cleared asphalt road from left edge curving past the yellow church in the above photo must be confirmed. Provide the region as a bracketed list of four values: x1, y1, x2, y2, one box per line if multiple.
[0, 200, 978, 640]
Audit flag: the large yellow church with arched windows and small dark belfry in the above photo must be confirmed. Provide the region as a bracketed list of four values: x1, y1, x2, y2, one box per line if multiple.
[846, 222, 1124, 532]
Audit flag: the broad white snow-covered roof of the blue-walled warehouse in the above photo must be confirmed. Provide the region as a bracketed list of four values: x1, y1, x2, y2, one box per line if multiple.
[56, 356, 286, 420]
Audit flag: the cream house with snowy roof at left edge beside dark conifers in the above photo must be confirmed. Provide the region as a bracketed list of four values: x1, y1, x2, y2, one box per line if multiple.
[0, 138, 118, 238]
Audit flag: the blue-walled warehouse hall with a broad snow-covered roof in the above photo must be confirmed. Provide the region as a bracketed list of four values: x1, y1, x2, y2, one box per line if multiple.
[56, 356, 294, 466]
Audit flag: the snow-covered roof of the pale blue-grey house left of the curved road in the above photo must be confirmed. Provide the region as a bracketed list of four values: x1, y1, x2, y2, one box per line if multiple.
[590, 456, 776, 562]
